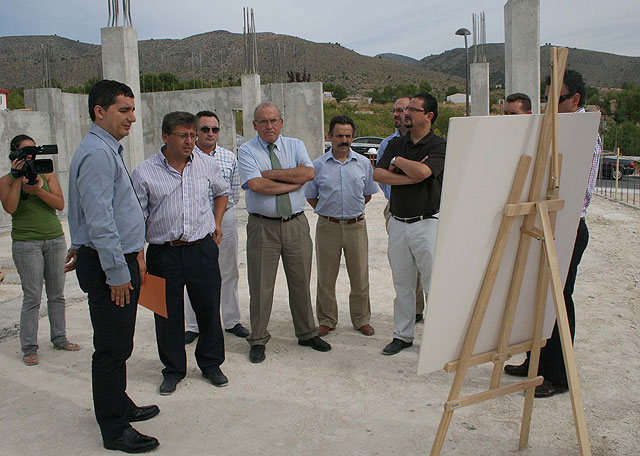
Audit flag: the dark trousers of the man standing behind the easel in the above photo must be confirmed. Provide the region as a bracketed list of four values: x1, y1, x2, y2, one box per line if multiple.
[527, 218, 589, 386]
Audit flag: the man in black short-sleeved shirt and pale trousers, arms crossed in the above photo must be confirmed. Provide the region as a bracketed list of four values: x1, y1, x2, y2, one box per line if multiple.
[373, 94, 446, 355]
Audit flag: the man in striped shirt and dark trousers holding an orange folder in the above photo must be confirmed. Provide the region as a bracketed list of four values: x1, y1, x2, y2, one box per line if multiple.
[132, 112, 229, 395]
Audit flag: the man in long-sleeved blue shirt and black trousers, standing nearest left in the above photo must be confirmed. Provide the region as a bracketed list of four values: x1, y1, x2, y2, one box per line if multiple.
[65, 80, 160, 453]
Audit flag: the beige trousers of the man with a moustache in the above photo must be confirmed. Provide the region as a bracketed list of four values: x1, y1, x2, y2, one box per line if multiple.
[316, 216, 371, 329]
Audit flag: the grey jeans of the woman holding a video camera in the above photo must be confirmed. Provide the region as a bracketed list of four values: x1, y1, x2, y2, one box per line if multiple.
[11, 236, 67, 355]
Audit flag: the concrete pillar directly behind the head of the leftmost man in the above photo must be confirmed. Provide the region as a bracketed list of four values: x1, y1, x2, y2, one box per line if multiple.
[100, 27, 144, 171]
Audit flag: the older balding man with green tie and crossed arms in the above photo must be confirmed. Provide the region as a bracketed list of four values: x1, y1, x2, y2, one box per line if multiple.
[238, 103, 331, 363]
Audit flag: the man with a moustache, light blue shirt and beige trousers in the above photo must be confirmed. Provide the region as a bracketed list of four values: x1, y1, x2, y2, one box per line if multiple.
[305, 116, 378, 336]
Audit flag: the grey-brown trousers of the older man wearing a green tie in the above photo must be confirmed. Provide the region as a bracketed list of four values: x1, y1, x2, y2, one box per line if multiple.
[247, 214, 318, 345]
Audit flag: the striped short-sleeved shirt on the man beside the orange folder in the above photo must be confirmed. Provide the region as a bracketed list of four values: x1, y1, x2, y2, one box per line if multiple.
[131, 146, 230, 244]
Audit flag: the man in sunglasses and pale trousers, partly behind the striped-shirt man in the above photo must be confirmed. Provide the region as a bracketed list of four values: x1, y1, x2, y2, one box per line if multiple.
[184, 111, 249, 344]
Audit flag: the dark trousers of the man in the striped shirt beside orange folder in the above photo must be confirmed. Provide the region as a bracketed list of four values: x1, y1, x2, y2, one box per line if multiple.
[147, 235, 224, 379]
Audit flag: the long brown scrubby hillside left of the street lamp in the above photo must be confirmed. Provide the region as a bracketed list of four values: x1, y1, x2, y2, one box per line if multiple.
[0, 30, 461, 93]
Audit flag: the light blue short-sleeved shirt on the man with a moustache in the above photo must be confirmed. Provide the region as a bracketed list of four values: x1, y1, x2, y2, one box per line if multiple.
[304, 149, 378, 219]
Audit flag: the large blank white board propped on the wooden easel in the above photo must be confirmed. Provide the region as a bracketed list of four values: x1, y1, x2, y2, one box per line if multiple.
[418, 113, 600, 374]
